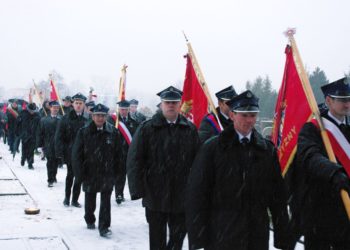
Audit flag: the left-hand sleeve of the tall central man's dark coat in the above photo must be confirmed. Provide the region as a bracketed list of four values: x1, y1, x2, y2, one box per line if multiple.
[126, 126, 146, 200]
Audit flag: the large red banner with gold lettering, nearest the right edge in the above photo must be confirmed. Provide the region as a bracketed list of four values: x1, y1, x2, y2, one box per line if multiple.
[272, 46, 312, 174]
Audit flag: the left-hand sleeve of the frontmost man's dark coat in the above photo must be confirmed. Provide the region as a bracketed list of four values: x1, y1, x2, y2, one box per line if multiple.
[185, 142, 213, 249]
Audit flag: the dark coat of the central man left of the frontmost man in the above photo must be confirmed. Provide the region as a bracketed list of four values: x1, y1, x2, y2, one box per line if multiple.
[127, 113, 199, 213]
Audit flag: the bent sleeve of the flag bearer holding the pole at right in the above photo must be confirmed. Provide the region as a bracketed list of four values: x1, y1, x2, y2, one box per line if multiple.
[297, 123, 341, 182]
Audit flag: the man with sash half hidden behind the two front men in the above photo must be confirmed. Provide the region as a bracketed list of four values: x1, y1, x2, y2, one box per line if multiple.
[198, 86, 237, 143]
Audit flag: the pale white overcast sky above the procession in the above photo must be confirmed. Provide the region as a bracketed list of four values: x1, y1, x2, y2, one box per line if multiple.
[0, 0, 350, 105]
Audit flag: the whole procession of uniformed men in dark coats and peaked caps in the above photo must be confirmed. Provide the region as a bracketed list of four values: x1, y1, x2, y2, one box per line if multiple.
[0, 78, 350, 250]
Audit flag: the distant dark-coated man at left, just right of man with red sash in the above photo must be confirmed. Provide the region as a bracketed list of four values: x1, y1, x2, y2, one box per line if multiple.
[16, 103, 40, 169]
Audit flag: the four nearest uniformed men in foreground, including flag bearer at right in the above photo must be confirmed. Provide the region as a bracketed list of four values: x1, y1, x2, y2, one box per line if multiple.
[127, 78, 350, 250]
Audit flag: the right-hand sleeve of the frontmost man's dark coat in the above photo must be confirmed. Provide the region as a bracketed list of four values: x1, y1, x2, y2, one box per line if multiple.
[269, 148, 289, 249]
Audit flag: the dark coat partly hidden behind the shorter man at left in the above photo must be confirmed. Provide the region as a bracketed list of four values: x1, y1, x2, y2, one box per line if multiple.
[55, 110, 87, 164]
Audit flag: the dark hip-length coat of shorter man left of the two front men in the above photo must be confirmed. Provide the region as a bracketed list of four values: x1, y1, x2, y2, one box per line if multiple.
[72, 122, 123, 193]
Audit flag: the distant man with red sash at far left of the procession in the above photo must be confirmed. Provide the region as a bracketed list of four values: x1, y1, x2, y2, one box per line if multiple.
[6, 99, 21, 153]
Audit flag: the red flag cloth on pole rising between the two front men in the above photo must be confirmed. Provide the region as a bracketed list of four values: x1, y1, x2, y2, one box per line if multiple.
[181, 54, 208, 128]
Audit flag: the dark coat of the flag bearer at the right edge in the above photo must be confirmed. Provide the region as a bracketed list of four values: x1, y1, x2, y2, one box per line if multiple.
[292, 114, 350, 242]
